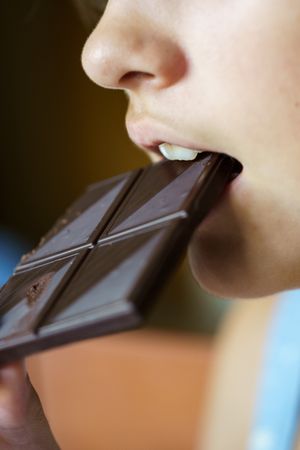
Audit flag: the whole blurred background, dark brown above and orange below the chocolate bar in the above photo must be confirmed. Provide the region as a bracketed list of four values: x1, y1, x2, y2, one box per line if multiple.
[0, 0, 230, 450]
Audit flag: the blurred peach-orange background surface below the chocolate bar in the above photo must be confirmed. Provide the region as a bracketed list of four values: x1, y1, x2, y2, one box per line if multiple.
[28, 330, 211, 450]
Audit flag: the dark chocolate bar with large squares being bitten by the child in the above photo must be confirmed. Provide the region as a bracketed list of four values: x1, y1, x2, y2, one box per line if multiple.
[0, 153, 236, 362]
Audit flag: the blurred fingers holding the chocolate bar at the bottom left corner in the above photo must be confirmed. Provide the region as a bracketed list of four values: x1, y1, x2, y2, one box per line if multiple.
[0, 362, 59, 450]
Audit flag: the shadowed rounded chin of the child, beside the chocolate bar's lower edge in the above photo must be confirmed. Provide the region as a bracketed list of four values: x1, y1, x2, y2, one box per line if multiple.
[188, 224, 291, 299]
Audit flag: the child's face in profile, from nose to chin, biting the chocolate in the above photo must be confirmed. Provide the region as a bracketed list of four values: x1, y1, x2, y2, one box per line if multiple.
[82, 0, 300, 297]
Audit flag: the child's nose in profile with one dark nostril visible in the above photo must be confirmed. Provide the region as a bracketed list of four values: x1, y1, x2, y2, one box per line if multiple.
[82, 7, 187, 90]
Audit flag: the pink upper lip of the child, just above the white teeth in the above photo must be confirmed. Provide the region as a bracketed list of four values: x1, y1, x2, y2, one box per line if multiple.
[126, 118, 217, 155]
